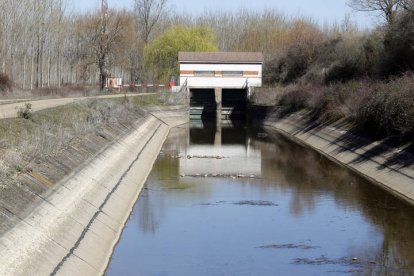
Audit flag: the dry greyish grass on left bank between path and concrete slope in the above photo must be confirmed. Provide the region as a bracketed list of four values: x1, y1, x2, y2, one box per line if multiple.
[0, 94, 181, 179]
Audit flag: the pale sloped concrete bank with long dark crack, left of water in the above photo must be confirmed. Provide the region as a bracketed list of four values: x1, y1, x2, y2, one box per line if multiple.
[0, 111, 188, 275]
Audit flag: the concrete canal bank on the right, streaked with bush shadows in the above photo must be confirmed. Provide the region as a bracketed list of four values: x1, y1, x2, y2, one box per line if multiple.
[264, 112, 414, 204]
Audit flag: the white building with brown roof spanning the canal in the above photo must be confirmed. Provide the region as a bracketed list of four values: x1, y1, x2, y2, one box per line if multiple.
[178, 52, 264, 89]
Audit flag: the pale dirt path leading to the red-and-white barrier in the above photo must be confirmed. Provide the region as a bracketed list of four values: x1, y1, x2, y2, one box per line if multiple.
[0, 93, 151, 119]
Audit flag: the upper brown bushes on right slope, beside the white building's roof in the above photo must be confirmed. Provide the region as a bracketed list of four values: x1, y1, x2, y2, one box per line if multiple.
[263, 30, 386, 85]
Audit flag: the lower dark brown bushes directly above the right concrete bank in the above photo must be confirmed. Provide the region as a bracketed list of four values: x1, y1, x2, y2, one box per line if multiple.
[279, 74, 414, 138]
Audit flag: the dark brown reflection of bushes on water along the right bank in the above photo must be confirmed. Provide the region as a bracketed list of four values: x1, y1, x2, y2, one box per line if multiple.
[262, 128, 414, 275]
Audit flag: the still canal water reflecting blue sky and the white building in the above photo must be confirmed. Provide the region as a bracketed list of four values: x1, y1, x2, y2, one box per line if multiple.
[106, 121, 414, 275]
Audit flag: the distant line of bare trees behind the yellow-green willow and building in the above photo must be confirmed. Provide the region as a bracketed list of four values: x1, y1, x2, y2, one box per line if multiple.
[0, 0, 357, 90]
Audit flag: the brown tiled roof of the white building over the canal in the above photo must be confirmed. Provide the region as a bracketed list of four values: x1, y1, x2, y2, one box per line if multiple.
[178, 52, 264, 63]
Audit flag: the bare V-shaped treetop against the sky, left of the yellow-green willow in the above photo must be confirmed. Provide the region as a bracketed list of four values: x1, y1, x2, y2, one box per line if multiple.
[135, 0, 168, 43]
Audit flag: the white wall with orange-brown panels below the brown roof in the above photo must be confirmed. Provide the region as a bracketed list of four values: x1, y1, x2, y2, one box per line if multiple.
[180, 63, 263, 88]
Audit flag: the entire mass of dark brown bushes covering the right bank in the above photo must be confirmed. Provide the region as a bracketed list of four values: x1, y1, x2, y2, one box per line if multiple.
[258, 0, 414, 141]
